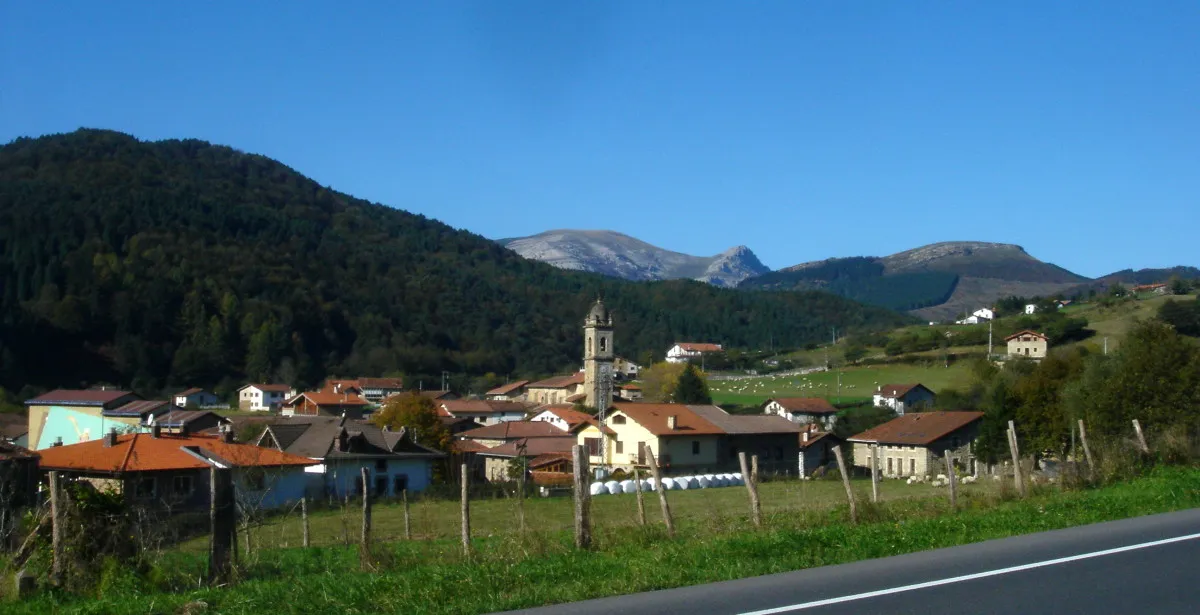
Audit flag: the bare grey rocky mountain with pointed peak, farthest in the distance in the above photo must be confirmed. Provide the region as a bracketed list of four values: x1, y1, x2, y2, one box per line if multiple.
[499, 229, 770, 288]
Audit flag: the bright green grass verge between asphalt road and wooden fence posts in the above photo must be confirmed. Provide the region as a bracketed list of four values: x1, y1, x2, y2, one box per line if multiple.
[14, 468, 1200, 615]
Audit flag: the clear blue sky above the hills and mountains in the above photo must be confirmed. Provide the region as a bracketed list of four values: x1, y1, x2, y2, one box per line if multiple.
[0, 0, 1200, 275]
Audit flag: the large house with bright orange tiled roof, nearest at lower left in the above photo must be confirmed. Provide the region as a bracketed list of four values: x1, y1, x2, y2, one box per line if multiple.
[38, 429, 316, 512]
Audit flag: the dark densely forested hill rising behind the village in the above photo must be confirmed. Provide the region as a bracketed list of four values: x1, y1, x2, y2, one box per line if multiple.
[0, 130, 906, 392]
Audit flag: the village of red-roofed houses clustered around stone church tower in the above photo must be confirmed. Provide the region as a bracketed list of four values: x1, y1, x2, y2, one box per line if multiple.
[0, 300, 1070, 523]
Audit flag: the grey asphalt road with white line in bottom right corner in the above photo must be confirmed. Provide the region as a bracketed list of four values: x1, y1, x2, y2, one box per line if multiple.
[501, 509, 1200, 615]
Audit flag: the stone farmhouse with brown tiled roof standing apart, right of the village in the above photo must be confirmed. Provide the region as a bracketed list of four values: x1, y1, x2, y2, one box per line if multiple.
[847, 412, 983, 477]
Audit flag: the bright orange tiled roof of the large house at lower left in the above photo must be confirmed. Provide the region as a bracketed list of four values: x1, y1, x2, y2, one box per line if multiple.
[38, 434, 317, 474]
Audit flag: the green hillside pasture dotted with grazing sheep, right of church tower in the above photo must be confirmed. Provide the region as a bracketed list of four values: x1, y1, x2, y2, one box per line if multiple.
[708, 360, 968, 405]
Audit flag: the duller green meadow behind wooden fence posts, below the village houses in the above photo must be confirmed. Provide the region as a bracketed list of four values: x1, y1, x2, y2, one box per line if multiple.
[196, 479, 996, 550]
